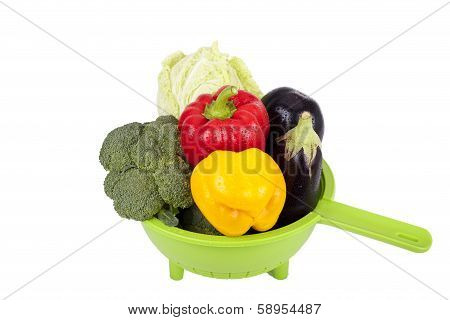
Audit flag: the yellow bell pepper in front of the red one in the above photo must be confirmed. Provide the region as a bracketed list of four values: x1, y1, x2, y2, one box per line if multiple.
[191, 148, 286, 236]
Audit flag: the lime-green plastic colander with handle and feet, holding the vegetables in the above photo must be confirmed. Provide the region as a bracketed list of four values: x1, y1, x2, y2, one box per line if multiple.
[142, 161, 431, 280]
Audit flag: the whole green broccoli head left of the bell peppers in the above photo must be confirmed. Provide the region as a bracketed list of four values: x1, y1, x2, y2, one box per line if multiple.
[99, 116, 193, 226]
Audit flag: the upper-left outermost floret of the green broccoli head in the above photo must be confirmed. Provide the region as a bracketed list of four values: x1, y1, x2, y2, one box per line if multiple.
[99, 122, 142, 171]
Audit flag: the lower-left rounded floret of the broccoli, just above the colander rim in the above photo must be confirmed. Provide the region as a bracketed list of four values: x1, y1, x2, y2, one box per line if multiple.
[109, 168, 165, 221]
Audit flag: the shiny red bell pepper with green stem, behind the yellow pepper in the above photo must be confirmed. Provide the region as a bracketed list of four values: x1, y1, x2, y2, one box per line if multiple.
[178, 86, 269, 167]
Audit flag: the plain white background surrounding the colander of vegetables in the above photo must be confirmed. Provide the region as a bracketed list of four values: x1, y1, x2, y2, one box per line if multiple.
[0, 0, 450, 319]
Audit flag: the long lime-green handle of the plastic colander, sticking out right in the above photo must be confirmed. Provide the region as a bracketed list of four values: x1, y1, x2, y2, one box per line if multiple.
[314, 199, 432, 252]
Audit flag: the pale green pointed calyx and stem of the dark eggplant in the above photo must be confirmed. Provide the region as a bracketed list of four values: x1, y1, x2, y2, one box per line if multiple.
[277, 111, 321, 176]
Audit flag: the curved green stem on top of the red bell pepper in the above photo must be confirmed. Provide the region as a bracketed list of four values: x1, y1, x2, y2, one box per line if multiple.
[203, 86, 238, 120]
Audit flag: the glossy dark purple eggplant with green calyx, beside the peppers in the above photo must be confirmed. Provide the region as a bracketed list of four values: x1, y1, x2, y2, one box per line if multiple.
[261, 87, 324, 227]
